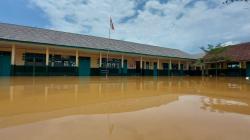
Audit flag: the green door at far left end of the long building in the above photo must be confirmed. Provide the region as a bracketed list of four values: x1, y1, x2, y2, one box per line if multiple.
[0, 55, 11, 76]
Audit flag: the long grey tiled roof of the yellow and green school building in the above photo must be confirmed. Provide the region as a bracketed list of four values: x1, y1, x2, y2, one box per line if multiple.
[0, 23, 195, 59]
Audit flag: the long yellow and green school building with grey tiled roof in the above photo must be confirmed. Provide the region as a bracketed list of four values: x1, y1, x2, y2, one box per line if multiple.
[0, 23, 201, 76]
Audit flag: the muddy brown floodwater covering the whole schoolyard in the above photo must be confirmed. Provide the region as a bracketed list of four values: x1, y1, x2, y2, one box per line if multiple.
[0, 77, 250, 140]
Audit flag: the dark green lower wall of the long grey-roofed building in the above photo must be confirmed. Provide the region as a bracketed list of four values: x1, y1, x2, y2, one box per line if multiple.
[8, 66, 201, 76]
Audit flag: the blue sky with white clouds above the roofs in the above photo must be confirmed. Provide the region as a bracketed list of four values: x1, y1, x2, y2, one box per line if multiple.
[0, 0, 250, 53]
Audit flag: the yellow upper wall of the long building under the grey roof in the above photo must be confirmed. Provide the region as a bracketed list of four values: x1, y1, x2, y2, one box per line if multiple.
[0, 45, 192, 70]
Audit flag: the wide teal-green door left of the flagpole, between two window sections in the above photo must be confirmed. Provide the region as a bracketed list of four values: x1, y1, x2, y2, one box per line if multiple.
[79, 57, 90, 76]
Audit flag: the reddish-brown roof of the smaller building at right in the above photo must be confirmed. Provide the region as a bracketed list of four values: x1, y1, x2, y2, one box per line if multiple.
[204, 42, 250, 61]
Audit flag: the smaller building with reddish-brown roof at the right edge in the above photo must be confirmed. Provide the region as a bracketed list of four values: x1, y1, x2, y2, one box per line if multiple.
[203, 43, 250, 77]
